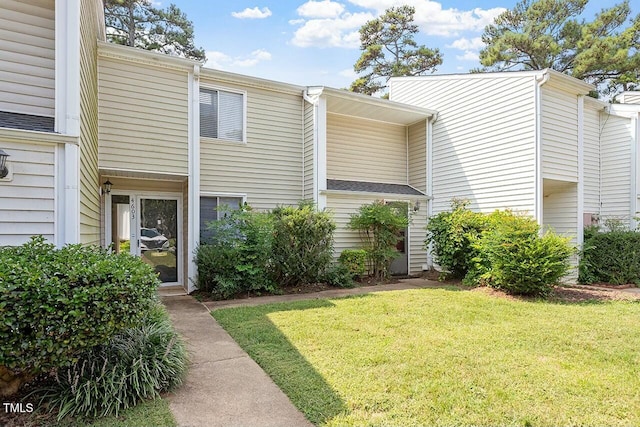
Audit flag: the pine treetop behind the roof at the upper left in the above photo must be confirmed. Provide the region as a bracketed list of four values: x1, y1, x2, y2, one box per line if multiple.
[104, 0, 205, 61]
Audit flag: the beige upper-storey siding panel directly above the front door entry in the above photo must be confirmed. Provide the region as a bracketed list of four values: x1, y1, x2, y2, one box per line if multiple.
[98, 57, 188, 174]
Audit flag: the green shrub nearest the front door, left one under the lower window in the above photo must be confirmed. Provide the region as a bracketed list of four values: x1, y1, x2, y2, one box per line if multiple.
[195, 206, 276, 298]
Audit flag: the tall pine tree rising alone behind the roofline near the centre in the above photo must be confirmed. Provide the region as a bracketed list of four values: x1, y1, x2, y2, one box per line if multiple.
[350, 6, 442, 95]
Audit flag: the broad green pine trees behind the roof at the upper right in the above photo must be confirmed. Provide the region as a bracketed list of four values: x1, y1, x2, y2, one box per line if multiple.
[480, 0, 640, 93]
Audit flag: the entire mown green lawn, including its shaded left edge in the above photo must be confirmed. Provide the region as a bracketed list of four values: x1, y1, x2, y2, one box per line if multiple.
[213, 289, 640, 426]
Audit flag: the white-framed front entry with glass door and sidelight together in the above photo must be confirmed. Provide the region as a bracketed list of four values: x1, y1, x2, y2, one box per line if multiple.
[108, 194, 182, 285]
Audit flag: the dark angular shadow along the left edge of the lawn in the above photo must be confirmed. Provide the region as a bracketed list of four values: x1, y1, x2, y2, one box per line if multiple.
[211, 295, 350, 425]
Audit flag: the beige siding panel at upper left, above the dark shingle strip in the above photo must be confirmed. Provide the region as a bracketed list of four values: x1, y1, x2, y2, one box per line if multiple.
[0, 0, 55, 117]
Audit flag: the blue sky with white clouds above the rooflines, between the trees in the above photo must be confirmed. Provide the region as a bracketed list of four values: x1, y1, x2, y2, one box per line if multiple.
[160, 0, 624, 88]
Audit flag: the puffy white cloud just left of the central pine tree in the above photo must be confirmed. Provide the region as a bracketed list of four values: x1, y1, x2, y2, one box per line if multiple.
[291, 13, 373, 48]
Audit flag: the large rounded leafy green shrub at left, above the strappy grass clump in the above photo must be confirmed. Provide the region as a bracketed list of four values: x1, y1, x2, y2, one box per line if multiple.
[0, 236, 159, 394]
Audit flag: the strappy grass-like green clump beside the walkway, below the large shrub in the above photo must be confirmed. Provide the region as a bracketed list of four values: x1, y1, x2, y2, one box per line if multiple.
[36, 304, 188, 420]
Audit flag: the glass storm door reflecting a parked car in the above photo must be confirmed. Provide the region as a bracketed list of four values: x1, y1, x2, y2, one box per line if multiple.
[135, 197, 180, 283]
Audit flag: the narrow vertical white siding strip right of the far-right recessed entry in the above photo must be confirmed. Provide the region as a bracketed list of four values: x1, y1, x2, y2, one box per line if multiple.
[584, 99, 602, 214]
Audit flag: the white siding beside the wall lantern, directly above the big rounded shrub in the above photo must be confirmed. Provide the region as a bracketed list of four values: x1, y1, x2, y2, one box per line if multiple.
[0, 136, 55, 242]
